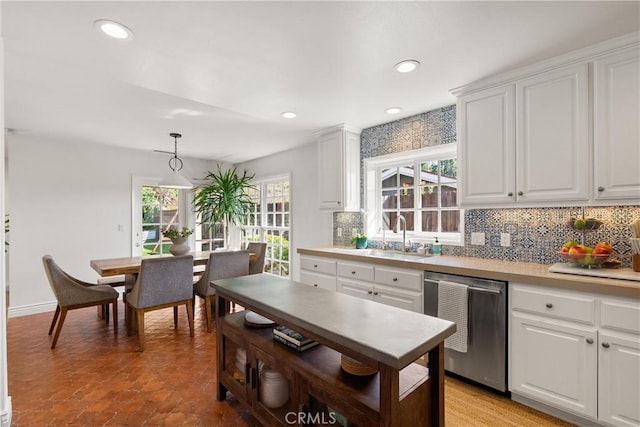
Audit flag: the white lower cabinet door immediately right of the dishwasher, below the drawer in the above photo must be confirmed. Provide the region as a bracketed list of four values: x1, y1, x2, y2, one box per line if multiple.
[511, 312, 598, 419]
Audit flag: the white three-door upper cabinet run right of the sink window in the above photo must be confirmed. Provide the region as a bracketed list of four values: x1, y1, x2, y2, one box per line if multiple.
[453, 34, 640, 208]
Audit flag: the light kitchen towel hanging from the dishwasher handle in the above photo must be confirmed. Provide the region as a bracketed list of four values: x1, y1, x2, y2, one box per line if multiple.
[438, 280, 469, 353]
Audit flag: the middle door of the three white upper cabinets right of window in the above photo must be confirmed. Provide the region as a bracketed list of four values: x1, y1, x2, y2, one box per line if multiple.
[516, 64, 592, 202]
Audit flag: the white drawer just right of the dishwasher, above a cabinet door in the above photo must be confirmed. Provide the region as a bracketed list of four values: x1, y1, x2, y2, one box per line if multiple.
[511, 286, 596, 325]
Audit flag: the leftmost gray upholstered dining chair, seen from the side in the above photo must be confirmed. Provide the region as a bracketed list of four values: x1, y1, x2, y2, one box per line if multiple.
[42, 255, 119, 348]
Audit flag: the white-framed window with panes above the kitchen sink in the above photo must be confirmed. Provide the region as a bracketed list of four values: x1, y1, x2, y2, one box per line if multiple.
[365, 144, 463, 244]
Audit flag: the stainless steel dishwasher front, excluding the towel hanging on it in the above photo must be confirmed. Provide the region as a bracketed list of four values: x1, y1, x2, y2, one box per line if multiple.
[424, 271, 507, 393]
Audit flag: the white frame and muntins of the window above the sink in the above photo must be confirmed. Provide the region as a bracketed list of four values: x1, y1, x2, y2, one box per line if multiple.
[363, 143, 464, 245]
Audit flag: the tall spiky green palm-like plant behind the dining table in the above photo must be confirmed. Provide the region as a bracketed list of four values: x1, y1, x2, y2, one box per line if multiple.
[193, 165, 254, 248]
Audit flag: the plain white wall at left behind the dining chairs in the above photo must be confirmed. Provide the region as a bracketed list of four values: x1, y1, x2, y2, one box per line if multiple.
[5, 135, 215, 317]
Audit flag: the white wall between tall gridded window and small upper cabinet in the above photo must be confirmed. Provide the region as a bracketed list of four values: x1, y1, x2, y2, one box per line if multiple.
[237, 144, 333, 280]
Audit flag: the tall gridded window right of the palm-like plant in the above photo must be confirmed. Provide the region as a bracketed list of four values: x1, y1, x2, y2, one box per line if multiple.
[241, 176, 291, 277]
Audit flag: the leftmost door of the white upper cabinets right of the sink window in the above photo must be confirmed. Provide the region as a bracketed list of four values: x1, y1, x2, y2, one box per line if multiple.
[457, 85, 515, 206]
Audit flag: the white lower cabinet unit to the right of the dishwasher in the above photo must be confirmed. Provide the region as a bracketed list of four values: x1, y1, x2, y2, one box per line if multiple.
[509, 283, 640, 426]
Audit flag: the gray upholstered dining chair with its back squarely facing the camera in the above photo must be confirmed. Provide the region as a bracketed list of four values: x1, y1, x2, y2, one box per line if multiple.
[126, 255, 193, 351]
